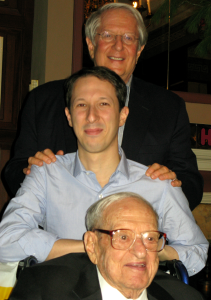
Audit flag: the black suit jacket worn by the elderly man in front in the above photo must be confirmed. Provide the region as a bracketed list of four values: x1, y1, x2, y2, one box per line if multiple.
[9, 253, 203, 300]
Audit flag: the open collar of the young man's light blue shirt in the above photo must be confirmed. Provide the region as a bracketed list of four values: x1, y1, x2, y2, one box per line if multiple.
[73, 147, 130, 179]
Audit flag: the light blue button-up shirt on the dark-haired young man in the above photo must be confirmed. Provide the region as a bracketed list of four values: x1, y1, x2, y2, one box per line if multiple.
[0, 149, 208, 275]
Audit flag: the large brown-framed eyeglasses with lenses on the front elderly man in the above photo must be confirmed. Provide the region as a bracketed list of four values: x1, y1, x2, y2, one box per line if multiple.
[93, 229, 166, 252]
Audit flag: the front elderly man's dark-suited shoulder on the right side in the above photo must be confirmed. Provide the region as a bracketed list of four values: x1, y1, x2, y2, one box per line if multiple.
[147, 270, 203, 300]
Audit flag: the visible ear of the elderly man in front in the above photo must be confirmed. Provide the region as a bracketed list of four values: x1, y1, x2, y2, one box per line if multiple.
[84, 231, 98, 265]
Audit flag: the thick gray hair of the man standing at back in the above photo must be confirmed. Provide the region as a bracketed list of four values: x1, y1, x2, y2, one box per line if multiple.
[85, 3, 148, 50]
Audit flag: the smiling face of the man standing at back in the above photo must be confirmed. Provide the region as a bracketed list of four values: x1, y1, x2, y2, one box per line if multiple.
[86, 9, 144, 83]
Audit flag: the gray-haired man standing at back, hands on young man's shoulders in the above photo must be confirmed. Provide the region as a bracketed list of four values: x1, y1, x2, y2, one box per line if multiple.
[2, 3, 203, 210]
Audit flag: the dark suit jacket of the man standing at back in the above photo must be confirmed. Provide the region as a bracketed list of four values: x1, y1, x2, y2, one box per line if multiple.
[4, 78, 203, 210]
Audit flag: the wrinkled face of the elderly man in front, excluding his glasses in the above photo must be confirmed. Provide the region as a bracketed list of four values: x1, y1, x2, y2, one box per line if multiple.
[85, 198, 159, 299]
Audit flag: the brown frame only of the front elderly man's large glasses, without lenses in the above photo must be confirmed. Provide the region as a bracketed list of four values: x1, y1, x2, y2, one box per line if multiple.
[92, 228, 167, 252]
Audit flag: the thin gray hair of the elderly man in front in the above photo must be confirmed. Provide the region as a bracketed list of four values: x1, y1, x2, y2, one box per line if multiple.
[85, 192, 158, 231]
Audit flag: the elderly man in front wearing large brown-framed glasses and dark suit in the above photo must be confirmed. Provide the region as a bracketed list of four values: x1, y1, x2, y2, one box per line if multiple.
[10, 193, 203, 300]
